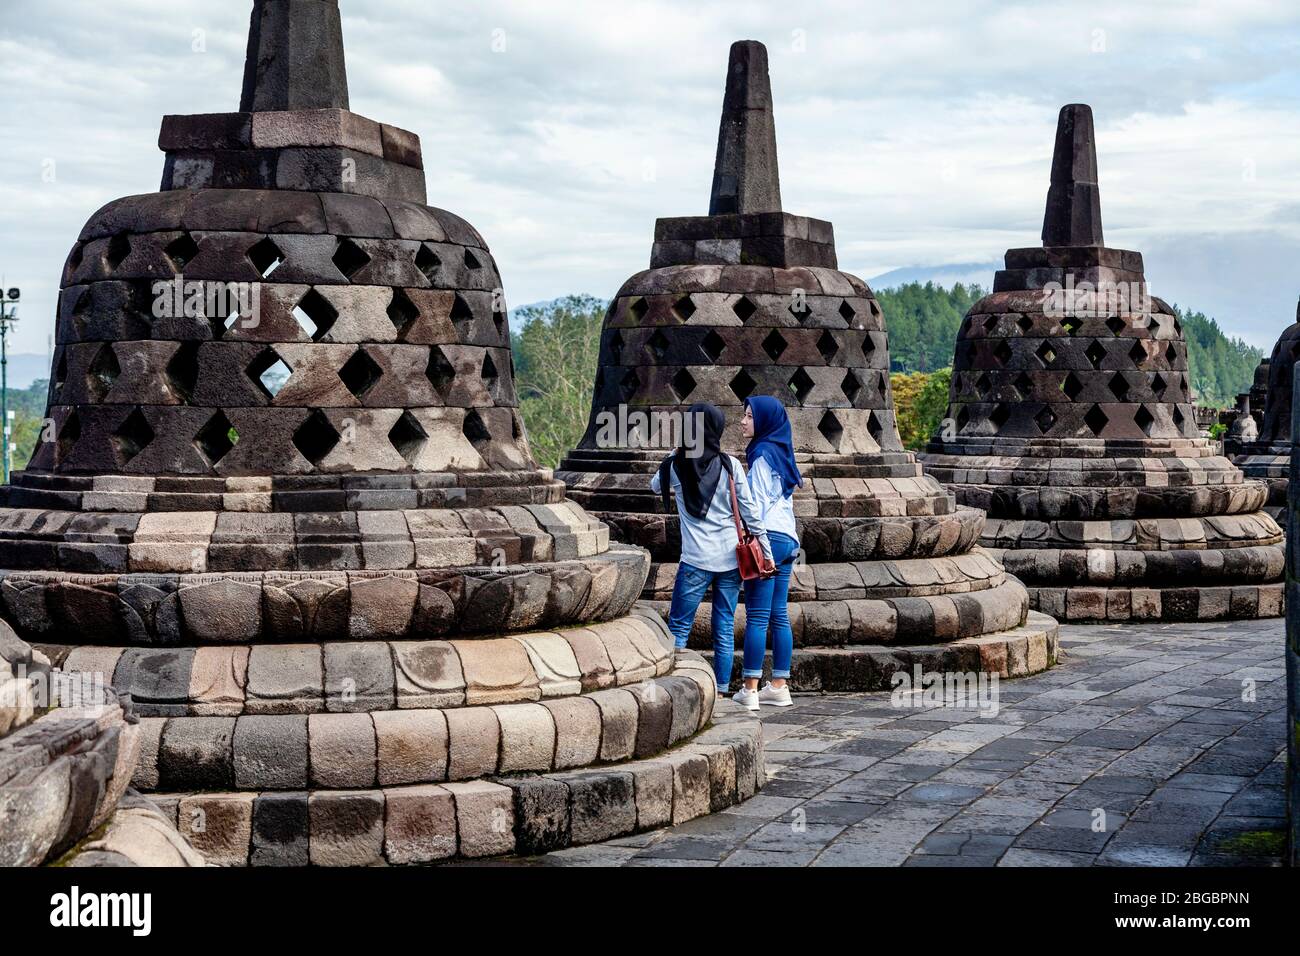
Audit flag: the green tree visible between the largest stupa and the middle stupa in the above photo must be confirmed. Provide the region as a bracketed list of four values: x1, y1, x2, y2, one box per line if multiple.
[511, 295, 608, 468]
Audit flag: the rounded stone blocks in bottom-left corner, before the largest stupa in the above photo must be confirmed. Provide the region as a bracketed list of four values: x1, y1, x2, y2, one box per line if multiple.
[0, 622, 204, 866]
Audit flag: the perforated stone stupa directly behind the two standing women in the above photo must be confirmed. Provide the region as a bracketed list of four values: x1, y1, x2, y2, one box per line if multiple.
[556, 42, 1056, 689]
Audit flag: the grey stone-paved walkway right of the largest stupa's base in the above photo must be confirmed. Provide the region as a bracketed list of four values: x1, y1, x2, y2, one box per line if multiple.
[527, 620, 1286, 866]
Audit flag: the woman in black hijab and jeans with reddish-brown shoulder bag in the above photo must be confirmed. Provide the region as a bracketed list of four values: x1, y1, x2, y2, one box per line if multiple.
[650, 402, 772, 693]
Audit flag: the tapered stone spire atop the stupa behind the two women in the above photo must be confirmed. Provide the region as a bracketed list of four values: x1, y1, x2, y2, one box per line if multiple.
[709, 40, 781, 216]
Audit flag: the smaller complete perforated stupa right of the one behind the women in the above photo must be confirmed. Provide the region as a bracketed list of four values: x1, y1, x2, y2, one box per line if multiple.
[922, 105, 1283, 620]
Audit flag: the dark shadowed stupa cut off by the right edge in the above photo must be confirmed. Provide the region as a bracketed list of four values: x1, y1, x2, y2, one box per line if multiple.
[1223, 307, 1300, 522]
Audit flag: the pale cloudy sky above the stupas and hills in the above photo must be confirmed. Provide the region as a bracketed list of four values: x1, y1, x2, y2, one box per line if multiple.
[0, 0, 1300, 354]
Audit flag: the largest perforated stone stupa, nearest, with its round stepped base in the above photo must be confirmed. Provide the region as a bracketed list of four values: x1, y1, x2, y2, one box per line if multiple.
[0, 0, 762, 865]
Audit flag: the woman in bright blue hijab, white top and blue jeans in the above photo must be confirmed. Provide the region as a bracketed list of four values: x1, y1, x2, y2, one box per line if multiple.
[733, 395, 803, 710]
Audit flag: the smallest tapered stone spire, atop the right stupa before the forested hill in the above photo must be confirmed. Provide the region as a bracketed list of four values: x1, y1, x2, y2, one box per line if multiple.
[1043, 103, 1105, 246]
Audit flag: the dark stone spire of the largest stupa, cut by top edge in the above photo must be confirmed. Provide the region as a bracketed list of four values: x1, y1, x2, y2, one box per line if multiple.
[239, 0, 348, 113]
